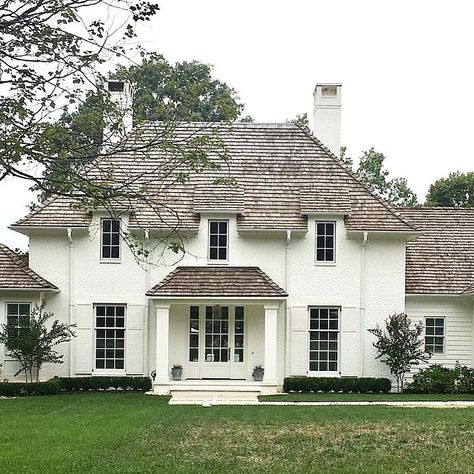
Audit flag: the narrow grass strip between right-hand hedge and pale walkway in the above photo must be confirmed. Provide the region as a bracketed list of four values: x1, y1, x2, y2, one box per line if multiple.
[259, 393, 474, 402]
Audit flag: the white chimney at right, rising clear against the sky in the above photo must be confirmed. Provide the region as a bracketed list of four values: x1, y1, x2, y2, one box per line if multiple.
[313, 83, 342, 156]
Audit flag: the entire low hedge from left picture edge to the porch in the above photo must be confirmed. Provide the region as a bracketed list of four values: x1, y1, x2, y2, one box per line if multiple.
[0, 377, 151, 397]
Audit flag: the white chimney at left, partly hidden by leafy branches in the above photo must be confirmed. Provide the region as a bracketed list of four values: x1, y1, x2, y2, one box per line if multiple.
[104, 80, 133, 145]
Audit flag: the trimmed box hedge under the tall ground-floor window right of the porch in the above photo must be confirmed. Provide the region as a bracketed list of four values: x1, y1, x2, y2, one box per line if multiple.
[283, 377, 392, 393]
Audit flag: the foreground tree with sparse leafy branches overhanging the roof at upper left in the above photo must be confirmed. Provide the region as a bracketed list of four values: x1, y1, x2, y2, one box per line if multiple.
[0, 0, 236, 262]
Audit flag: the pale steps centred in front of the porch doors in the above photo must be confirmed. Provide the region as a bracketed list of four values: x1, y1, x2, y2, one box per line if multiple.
[169, 386, 261, 406]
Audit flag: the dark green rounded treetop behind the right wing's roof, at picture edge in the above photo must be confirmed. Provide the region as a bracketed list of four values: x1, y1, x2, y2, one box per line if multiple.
[425, 171, 474, 207]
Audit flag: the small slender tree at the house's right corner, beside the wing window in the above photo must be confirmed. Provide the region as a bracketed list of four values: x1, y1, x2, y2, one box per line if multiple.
[368, 313, 431, 392]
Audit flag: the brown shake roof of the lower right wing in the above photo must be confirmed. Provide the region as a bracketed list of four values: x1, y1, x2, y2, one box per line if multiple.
[399, 207, 474, 295]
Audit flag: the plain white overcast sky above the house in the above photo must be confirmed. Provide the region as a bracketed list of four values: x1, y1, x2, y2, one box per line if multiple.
[0, 0, 474, 248]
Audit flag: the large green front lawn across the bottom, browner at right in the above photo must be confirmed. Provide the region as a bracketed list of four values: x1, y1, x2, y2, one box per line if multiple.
[0, 393, 474, 474]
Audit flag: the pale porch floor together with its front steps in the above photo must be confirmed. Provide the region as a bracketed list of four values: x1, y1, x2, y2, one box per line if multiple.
[150, 379, 278, 405]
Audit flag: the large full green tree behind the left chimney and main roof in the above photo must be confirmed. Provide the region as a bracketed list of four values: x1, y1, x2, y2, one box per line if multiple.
[36, 53, 244, 202]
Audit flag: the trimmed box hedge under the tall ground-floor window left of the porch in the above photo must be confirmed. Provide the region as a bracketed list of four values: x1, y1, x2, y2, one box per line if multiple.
[53, 377, 151, 392]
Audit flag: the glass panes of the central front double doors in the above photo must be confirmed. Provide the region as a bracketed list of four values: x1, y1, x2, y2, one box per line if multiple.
[205, 305, 229, 362]
